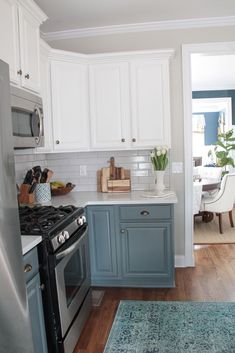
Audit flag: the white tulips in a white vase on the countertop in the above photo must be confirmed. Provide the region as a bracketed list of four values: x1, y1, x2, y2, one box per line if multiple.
[150, 146, 168, 192]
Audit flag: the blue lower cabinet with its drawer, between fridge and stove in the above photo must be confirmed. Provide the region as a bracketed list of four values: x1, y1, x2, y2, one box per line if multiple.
[23, 248, 48, 353]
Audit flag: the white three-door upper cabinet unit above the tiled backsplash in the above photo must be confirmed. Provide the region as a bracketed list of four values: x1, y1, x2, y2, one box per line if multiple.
[51, 50, 173, 151]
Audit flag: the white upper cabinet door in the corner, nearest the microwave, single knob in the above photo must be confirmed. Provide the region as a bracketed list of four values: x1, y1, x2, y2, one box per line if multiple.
[51, 61, 89, 151]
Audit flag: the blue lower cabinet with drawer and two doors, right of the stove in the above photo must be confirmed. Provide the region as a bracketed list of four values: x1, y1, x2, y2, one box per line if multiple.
[87, 204, 174, 287]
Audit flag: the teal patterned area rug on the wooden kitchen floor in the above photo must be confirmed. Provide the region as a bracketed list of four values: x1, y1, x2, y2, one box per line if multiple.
[104, 300, 235, 353]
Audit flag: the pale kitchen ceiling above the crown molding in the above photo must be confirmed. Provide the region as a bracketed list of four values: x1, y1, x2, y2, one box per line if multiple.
[35, 0, 235, 33]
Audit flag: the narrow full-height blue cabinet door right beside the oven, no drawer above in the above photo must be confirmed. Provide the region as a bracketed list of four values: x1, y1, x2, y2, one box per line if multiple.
[87, 206, 118, 285]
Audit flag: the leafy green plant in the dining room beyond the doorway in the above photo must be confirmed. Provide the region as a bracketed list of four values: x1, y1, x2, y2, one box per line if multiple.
[215, 129, 235, 175]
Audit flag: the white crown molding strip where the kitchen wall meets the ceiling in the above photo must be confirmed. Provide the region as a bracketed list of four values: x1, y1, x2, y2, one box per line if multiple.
[41, 16, 235, 42]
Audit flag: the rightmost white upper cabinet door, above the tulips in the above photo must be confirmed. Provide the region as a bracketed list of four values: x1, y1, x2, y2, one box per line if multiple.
[130, 59, 170, 148]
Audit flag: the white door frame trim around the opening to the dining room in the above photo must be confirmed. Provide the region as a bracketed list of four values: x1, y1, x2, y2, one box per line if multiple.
[182, 42, 235, 266]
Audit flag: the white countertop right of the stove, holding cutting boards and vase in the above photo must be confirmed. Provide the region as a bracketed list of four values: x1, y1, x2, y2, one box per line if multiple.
[51, 191, 178, 207]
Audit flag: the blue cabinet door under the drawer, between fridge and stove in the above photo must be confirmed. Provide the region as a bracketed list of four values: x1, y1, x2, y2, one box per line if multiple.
[26, 274, 47, 353]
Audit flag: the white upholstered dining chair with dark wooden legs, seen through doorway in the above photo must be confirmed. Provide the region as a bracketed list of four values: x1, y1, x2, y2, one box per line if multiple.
[201, 173, 235, 234]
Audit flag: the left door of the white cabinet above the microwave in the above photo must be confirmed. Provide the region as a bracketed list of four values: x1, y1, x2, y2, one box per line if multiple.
[0, 0, 21, 84]
